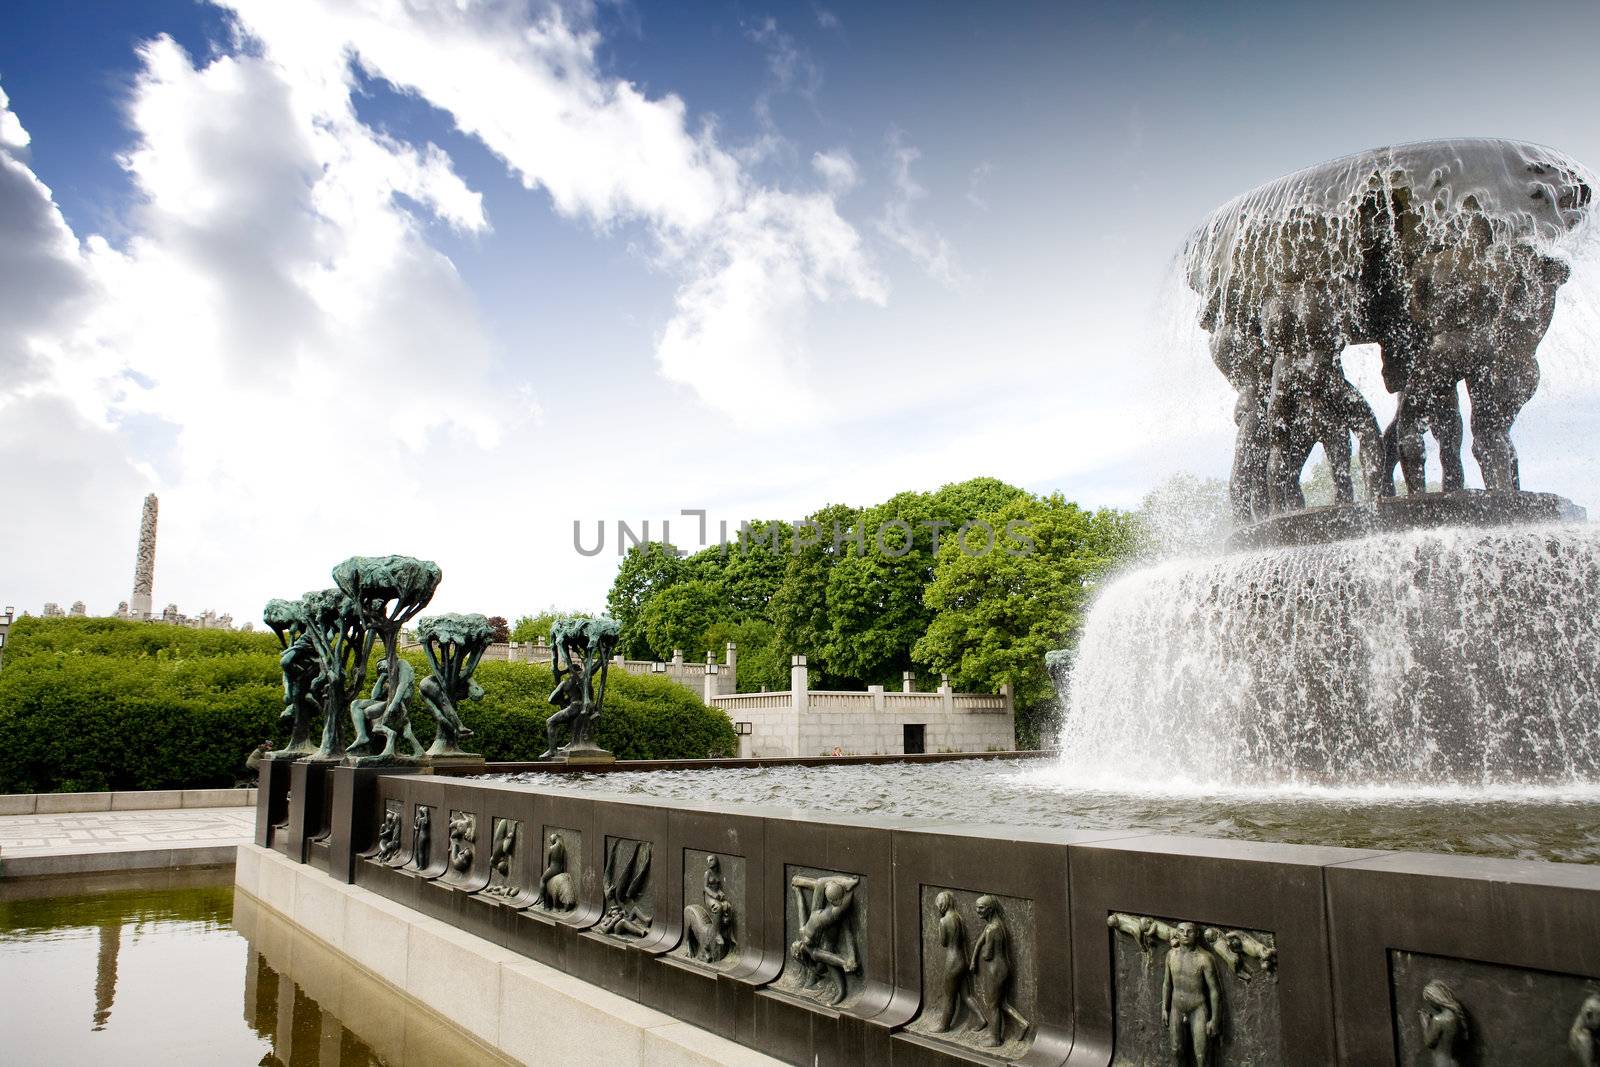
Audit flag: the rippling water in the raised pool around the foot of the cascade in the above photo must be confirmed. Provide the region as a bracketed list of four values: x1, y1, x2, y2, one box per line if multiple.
[492, 758, 1600, 864]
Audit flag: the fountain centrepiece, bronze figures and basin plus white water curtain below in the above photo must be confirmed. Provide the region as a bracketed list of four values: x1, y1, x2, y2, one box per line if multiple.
[1061, 141, 1600, 790]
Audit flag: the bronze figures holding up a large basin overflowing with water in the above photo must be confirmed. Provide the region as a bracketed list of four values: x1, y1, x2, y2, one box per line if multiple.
[1186, 139, 1594, 522]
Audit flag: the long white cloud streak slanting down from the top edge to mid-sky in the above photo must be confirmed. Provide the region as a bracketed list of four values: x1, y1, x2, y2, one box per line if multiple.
[214, 0, 885, 421]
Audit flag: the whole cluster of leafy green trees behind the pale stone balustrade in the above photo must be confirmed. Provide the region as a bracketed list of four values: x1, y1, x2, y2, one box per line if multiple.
[595, 478, 1139, 744]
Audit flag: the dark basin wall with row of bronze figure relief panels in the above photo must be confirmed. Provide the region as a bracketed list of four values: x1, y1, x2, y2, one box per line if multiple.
[256, 763, 1600, 1067]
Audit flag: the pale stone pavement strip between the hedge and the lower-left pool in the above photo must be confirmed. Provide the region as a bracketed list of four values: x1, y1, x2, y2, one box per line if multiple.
[0, 808, 256, 878]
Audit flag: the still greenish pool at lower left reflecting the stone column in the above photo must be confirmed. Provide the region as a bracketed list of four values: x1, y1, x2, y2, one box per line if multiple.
[0, 869, 507, 1067]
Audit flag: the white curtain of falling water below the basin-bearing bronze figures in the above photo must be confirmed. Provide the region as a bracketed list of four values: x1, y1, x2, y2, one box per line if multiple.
[1056, 525, 1600, 795]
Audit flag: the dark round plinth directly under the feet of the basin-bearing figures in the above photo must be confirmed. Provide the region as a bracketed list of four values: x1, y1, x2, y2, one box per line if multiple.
[1227, 490, 1589, 549]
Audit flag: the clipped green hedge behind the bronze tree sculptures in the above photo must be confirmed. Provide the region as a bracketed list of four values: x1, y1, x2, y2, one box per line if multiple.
[0, 617, 736, 793]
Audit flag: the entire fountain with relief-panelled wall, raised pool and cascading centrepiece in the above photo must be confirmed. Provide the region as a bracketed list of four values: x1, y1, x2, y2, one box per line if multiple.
[235, 141, 1600, 1067]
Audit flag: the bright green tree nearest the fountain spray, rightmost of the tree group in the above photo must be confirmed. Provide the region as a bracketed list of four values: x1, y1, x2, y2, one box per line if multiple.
[912, 493, 1138, 747]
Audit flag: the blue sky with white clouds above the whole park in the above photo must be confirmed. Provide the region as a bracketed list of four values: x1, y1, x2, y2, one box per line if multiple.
[0, 0, 1600, 617]
